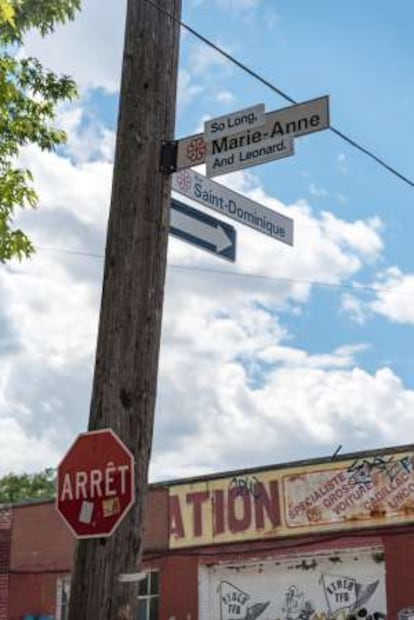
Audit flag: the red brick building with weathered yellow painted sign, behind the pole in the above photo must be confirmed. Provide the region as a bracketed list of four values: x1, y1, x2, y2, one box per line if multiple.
[0, 446, 414, 620]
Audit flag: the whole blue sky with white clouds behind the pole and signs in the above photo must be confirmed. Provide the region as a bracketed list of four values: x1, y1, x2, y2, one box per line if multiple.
[0, 0, 414, 481]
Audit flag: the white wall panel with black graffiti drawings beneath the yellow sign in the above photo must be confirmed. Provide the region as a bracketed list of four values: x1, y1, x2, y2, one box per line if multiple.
[200, 549, 387, 620]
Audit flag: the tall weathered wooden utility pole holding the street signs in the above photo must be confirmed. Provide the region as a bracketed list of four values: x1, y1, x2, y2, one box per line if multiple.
[69, 0, 181, 620]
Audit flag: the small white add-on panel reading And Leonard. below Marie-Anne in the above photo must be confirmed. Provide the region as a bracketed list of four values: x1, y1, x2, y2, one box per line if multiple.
[207, 136, 294, 177]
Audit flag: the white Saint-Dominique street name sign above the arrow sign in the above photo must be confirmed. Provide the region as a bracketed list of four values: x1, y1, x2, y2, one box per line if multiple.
[172, 170, 293, 245]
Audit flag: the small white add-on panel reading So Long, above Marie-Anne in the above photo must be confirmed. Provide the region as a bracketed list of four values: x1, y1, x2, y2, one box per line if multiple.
[204, 103, 265, 141]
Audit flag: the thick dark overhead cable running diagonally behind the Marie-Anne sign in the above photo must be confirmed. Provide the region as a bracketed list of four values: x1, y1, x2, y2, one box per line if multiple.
[145, 0, 414, 187]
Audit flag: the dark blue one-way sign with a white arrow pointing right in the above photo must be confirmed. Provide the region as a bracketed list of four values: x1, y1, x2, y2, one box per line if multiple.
[170, 198, 236, 262]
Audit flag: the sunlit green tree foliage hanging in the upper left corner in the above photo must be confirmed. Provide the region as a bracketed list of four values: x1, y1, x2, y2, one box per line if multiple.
[0, 0, 80, 262]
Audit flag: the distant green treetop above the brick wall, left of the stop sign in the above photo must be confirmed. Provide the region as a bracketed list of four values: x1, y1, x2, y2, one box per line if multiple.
[0, 468, 56, 504]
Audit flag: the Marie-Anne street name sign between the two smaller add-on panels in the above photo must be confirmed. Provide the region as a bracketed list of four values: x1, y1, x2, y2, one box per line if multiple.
[174, 96, 329, 170]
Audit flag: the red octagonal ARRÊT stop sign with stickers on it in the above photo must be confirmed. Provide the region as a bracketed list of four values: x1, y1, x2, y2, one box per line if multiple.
[56, 428, 135, 538]
